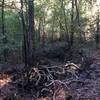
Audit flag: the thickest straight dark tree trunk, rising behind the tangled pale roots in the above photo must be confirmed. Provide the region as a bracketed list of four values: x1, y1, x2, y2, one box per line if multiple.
[28, 0, 35, 67]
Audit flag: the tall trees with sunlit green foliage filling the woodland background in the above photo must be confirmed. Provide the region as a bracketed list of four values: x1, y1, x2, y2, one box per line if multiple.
[0, 0, 100, 66]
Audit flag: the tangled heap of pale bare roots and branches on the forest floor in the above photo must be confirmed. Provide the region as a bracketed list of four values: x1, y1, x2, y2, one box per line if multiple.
[0, 56, 94, 100]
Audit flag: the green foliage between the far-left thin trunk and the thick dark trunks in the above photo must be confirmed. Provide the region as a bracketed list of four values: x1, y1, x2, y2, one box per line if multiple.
[0, 10, 23, 53]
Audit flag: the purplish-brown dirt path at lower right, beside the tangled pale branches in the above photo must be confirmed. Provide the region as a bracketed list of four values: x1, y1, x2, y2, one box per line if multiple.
[71, 51, 100, 100]
